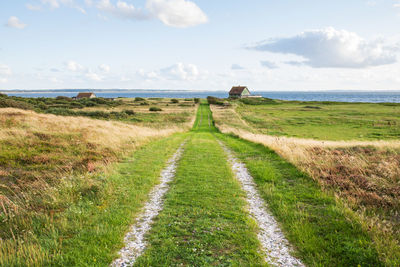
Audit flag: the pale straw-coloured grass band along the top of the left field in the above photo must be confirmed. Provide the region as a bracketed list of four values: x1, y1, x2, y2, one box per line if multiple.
[0, 108, 186, 148]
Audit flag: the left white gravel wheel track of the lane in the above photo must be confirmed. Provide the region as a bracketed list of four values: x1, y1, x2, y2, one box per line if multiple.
[111, 141, 186, 267]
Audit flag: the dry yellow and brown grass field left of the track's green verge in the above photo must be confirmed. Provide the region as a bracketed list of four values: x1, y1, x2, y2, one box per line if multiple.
[0, 108, 194, 246]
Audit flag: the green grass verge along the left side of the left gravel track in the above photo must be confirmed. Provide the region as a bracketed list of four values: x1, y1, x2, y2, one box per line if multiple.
[0, 134, 185, 266]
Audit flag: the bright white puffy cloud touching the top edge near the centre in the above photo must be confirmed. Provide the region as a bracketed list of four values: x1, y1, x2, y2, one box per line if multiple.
[146, 0, 208, 28]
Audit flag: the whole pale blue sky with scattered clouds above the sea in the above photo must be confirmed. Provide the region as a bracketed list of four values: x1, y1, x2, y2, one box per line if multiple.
[0, 0, 400, 91]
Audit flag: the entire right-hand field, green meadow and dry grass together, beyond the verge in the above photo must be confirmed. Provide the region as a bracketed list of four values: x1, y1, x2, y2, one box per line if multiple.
[212, 99, 400, 266]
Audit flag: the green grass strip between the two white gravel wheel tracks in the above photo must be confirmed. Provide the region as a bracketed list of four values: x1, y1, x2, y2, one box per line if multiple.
[136, 105, 263, 266]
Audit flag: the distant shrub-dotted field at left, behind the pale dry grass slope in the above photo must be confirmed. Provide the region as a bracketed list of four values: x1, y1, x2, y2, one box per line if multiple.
[0, 94, 198, 129]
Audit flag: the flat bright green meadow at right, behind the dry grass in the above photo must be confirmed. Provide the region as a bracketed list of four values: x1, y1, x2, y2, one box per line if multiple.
[236, 101, 400, 140]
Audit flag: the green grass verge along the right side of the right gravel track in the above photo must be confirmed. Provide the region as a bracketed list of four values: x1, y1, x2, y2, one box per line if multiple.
[218, 134, 383, 266]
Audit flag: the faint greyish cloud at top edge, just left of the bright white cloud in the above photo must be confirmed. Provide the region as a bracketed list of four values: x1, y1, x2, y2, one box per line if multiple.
[96, 0, 148, 19]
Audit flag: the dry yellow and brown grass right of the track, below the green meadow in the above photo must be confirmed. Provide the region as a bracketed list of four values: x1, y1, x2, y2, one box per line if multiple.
[212, 106, 400, 262]
